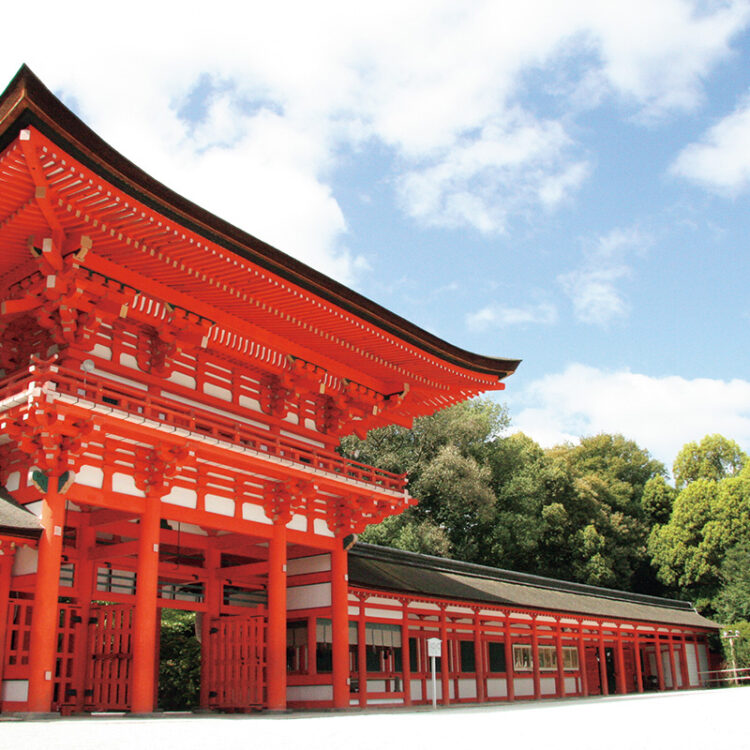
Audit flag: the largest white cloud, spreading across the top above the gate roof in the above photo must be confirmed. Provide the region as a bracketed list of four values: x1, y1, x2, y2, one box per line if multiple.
[0, 0, 750, 270]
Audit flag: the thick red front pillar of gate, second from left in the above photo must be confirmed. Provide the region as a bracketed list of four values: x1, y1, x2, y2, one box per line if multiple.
[130, 496, 161, 714]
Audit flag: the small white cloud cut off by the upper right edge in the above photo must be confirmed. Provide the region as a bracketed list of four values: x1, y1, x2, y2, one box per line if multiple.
[670, 97, 750, 195]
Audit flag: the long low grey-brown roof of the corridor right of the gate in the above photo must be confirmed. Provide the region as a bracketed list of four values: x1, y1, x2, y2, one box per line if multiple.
[349, 543, 719, 629]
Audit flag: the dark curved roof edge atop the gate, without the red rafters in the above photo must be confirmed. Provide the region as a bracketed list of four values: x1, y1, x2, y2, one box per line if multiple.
[0, 65, 520, 396]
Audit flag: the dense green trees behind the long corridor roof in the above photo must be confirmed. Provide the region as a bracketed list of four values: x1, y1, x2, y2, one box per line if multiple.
[342, 400, 750, 666]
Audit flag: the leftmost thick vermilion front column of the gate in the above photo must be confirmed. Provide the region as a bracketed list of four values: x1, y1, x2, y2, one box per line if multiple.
[29, 476, 65, 713]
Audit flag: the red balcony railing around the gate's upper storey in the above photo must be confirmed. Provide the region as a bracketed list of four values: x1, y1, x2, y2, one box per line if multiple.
[0, 363, 406, 492]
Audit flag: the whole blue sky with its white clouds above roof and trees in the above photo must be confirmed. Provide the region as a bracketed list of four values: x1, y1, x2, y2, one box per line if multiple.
[5, 0, 750, 465]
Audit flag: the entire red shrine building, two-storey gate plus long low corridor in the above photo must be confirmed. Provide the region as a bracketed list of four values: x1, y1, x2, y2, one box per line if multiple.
[0, 67, 714, 714]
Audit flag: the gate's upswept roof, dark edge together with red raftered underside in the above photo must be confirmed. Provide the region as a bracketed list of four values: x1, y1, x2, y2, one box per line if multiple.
[0, 67, 519, 405]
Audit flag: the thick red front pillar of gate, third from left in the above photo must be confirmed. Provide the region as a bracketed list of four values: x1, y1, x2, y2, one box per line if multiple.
[266, 518, 286, 711]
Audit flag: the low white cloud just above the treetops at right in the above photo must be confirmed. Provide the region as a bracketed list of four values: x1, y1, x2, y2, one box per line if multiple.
[510, 364, 750, 468]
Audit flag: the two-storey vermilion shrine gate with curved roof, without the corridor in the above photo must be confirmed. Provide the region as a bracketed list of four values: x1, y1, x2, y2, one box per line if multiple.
[0, 68, 518, 713]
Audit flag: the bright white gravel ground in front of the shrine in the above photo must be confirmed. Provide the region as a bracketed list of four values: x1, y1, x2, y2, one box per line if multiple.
[0, 688, 750, 750]
